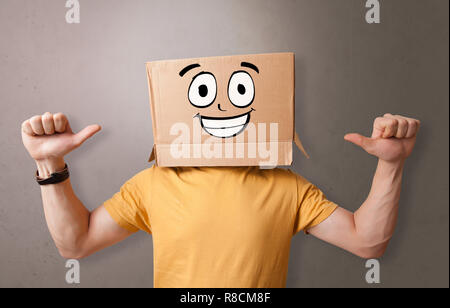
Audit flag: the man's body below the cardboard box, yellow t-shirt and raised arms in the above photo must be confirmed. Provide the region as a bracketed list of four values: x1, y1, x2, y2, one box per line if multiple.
[22, 113, 420, 287]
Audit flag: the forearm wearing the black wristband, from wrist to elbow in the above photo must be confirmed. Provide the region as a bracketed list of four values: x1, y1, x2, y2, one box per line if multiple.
[37, 159, 90, 256]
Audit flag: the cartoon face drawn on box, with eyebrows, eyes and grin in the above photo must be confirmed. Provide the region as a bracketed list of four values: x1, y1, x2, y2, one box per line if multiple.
[179, 62, 259, 138]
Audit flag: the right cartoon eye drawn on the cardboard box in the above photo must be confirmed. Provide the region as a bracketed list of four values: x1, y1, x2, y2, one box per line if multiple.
[228, 71, 255, 108]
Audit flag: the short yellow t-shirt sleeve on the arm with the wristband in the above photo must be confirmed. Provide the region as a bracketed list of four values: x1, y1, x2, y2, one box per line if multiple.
[103, 176, 151, 234]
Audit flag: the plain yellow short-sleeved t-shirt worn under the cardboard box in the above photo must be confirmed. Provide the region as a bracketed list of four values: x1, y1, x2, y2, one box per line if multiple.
[104, 167, 337, 288]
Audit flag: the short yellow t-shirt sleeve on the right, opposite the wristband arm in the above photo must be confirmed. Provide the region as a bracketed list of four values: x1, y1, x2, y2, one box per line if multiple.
[294, 175, 338, 234]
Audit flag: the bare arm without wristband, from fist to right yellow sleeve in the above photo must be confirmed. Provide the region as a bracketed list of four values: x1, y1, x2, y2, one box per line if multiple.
[308, 114, 420, 258]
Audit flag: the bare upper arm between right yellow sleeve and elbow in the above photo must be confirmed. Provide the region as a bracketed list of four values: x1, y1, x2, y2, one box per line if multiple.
[307, 207, 359, 254]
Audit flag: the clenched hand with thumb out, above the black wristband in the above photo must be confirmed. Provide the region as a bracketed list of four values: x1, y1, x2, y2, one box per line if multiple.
[22, 112, 101, 162]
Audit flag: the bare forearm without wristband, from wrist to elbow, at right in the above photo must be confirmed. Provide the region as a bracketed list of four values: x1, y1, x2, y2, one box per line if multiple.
[354, 160, 404, 254]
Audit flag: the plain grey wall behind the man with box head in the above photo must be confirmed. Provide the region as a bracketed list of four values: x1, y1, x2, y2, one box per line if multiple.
[0, 0, 449, 287]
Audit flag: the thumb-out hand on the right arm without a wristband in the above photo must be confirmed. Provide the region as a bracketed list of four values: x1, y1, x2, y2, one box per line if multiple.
[344, 113, 420, 162]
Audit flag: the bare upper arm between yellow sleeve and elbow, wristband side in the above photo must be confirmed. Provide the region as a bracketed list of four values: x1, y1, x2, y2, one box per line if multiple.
[78, 205, 134, 257]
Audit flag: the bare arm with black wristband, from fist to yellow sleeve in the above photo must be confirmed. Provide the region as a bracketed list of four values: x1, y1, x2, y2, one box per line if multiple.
[22, 113, 131, 259]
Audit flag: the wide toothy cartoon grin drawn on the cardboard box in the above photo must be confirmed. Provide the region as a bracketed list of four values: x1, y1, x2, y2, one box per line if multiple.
[197, 110, 253, 138]
